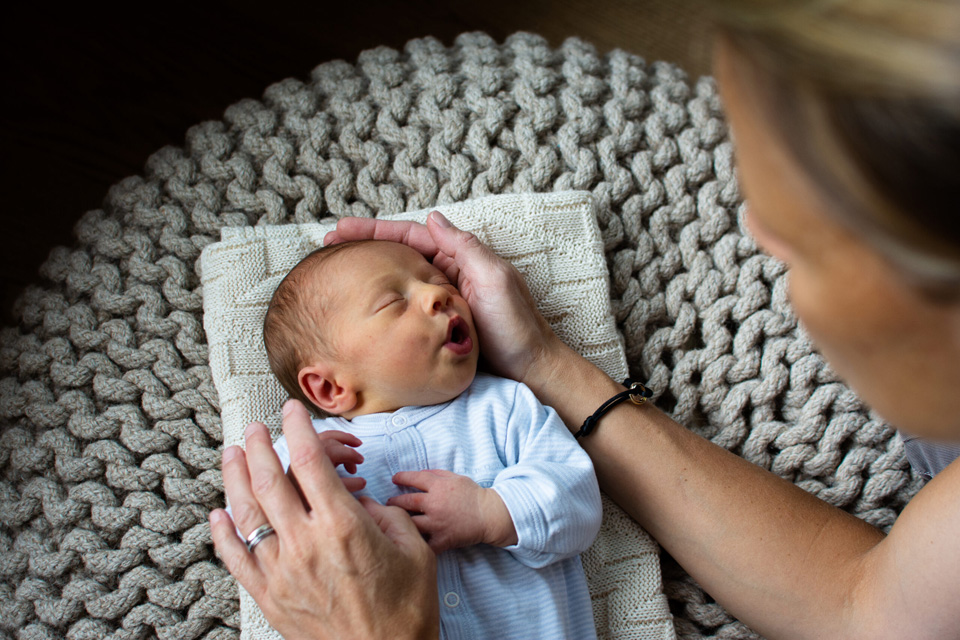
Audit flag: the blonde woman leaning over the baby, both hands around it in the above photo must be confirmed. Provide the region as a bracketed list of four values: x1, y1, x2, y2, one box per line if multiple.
[211, 0, 960, 638]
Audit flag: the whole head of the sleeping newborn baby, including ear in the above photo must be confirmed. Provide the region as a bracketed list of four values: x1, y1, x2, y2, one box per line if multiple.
[263, 240, 479, 418]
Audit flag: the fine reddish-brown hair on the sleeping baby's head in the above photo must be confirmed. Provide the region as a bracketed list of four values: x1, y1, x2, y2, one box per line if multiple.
[263, 240, 372, 417]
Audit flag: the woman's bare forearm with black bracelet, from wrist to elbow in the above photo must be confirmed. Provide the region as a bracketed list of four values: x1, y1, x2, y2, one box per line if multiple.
[524, 346, 883, 637]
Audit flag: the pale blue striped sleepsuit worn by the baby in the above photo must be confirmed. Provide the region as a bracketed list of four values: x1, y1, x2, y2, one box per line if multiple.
[275, 374, 601, 640]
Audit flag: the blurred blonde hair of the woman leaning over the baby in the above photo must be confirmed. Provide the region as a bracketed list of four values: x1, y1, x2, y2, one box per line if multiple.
[709, 0, 960, 300]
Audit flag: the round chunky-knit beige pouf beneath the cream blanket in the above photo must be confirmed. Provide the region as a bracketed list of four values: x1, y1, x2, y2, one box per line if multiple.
[0, 33, 920, 640]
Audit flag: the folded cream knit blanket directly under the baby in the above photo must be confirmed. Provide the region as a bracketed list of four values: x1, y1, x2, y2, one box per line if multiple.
[201, 191, 674, 640]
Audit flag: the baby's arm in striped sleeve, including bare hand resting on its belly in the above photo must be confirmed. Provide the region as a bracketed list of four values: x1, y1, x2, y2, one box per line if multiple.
[387, 385, 602, 567]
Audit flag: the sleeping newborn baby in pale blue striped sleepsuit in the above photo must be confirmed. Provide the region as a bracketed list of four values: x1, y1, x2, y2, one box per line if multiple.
[264, 241, 601, 639]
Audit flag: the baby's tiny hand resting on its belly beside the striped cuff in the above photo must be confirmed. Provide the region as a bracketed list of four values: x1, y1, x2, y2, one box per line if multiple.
[387, 469, 517, 553]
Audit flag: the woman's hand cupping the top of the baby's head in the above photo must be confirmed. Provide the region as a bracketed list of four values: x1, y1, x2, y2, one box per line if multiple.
[324, 211, 563, 386]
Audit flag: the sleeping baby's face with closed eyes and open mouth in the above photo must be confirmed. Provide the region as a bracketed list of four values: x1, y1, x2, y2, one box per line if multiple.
[322, 242, 480, 414]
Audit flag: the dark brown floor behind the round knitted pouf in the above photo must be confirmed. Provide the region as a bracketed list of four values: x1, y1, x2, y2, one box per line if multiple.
[0, 0, 709, 325]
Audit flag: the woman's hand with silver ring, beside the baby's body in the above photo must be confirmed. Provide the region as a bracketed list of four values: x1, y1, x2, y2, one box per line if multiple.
[210, 400, 439, 639]
